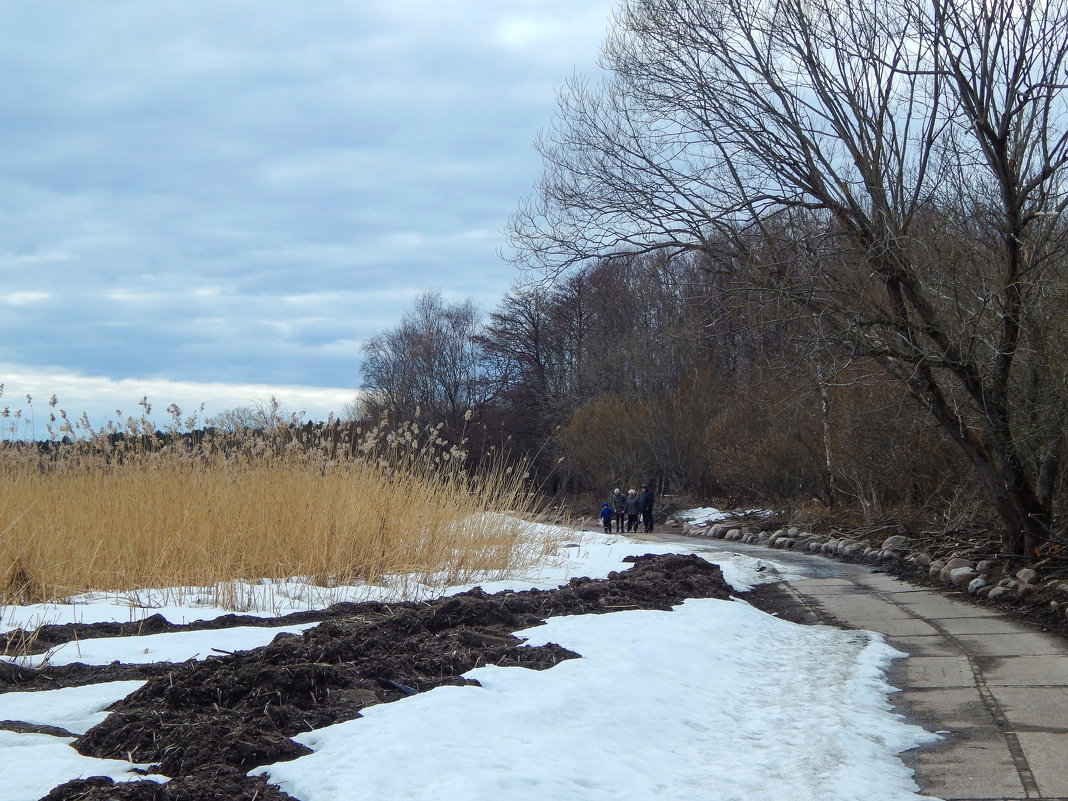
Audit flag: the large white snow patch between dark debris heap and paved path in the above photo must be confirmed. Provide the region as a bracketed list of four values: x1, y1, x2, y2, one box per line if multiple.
[258, 600, 935, 801]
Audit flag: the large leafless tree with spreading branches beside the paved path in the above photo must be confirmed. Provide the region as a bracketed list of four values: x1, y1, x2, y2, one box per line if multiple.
[511, 0, 1068, 555]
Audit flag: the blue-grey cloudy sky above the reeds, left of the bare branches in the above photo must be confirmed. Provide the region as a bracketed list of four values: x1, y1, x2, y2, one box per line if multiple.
[0, 0, 614, 434]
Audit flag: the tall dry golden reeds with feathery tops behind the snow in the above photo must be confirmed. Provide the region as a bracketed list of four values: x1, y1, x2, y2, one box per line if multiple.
[0, 403, 547, 610]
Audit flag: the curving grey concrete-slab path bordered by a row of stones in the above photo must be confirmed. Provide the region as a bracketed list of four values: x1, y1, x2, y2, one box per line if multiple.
[623, 537, 1068, 801]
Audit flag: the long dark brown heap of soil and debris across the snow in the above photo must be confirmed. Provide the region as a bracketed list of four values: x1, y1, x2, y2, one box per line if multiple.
[0, 554, 732, 801]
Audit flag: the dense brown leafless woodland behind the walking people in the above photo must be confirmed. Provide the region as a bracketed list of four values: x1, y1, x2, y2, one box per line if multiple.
[358, 255, 979, 523]
